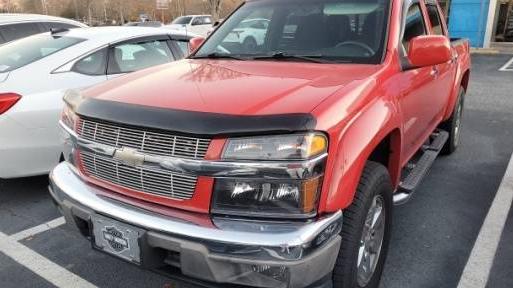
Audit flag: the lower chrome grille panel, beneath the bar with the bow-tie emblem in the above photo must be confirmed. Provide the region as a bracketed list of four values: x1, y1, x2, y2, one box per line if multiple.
[80, 151, 197, 200]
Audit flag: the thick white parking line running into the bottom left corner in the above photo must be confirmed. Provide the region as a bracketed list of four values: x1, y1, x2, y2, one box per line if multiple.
[0, 232, 96, 288]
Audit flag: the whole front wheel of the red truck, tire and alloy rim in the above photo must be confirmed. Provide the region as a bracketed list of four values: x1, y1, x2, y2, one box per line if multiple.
[333, 162, 393, 288]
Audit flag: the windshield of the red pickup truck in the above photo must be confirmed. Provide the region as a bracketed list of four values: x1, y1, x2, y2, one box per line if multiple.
[192, 0, 390, 64]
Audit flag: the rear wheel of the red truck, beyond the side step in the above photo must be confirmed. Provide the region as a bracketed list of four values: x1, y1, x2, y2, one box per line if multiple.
[440, 87, 465, 155]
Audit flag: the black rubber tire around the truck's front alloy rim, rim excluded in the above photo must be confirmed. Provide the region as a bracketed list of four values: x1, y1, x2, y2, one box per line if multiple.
[333, 162, 393, 288]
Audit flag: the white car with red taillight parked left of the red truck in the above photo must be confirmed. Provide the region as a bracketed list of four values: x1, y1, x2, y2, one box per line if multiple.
[0, 27, 191, 178]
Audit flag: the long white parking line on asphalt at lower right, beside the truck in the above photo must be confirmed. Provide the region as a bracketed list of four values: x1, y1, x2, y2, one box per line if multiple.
[458, 152, 513, 288]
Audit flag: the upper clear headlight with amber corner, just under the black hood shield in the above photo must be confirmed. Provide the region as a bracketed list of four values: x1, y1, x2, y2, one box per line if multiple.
[223, 132, 328, 160]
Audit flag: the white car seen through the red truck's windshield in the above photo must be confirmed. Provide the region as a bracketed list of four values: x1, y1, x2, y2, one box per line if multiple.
[223, 18, 269, 51]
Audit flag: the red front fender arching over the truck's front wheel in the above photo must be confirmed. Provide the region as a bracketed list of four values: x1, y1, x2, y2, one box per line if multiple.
[318, 79, 401, 213]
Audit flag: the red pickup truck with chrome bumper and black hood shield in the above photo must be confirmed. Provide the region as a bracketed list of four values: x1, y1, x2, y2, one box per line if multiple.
[50, 0, 470, 288]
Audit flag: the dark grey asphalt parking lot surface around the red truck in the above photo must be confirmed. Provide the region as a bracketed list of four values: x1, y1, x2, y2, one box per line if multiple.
[0, 55, 513, 288]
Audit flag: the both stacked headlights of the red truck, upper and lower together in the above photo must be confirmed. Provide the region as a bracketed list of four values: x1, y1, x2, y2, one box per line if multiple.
[212, 132, 328, 218]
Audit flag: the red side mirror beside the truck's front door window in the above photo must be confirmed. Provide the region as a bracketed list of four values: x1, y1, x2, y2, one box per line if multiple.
[408, 35, 452, 67]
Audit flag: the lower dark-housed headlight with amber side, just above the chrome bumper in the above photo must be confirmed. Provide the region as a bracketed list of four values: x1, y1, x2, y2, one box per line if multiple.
[212, 177, 322, 218]
